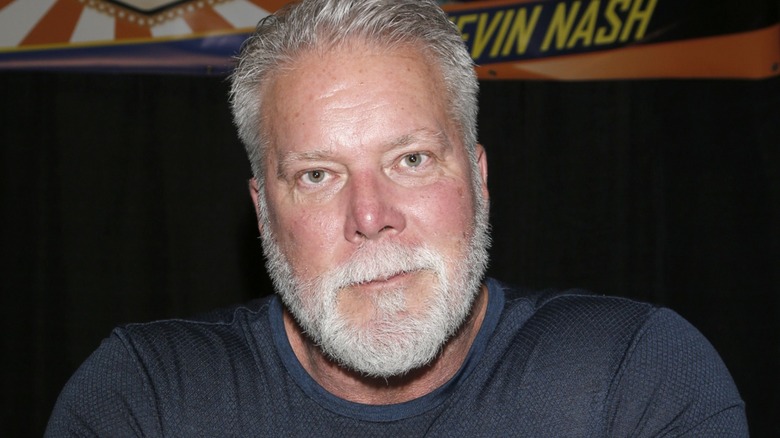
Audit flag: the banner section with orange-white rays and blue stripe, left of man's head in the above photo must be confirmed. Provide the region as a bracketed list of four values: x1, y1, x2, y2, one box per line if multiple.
[0, 0, 287, 74]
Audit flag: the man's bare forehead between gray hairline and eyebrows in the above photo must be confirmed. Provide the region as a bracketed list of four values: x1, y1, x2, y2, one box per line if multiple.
[263, 43, 450, 149]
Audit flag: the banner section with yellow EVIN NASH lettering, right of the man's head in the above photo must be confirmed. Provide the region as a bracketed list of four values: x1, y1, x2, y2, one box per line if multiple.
[446, 0, 780, 80]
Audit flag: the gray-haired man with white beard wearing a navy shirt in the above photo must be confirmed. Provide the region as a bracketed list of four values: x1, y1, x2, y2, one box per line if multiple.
[47, 0, 747, 436]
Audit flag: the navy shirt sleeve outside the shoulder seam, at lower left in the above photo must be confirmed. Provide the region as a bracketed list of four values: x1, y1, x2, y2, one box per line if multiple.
[44, 331, 162, 437]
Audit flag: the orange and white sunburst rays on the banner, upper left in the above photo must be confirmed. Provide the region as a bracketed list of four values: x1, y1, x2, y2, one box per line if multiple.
[0, 0, 286, 50]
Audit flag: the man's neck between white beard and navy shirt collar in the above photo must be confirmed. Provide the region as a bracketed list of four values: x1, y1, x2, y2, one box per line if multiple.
[284, 285, 488, 405]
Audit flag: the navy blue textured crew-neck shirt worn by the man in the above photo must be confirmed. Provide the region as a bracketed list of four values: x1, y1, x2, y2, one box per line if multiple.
[46, 279, 748, 437]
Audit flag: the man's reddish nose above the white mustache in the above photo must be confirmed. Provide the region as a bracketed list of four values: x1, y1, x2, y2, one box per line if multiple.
[344, 174, 406, 244]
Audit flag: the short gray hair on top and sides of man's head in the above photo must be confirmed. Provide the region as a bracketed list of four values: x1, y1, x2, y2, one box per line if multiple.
[230, 0, 479, 186]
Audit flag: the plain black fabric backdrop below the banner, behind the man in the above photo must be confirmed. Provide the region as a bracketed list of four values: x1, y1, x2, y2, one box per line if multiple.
[0, 73, 780, 436]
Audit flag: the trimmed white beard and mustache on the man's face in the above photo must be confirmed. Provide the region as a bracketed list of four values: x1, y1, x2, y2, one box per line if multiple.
[261, 181, 490, 378]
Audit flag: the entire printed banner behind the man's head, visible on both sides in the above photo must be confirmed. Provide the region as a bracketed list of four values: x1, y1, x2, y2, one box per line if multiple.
[0, 0, 780, 80]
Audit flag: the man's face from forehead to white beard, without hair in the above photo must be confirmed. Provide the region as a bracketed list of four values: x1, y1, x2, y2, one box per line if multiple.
[254, 42, 488, 377]
